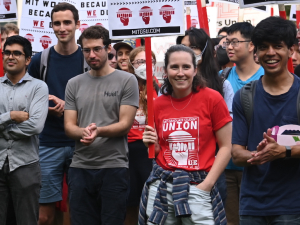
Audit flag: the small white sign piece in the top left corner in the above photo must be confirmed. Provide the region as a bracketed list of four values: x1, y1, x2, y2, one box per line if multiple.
[0, 0, 17, 22]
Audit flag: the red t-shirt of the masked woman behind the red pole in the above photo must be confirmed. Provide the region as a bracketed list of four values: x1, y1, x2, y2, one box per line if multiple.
[128, 90, 157, 143]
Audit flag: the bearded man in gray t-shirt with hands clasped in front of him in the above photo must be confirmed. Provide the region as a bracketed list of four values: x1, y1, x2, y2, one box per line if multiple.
[65, 26, 139, 225]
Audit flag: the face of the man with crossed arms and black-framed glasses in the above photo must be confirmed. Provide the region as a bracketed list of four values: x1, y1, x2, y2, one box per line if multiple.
[3, 44, 31, 76]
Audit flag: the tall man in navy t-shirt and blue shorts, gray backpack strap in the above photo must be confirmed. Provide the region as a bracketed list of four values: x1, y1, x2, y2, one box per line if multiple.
[28, 3, 84, 225]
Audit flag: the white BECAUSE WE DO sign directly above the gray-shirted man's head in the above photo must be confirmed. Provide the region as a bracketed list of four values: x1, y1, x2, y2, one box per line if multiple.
[76, 0, 108, 33]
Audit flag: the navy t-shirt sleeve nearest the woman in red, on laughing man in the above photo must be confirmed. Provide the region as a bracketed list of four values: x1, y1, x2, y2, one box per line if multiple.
[232, 90, 249, 146]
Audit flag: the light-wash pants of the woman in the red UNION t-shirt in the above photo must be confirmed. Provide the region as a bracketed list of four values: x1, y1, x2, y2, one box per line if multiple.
[146, 180, 215, 225]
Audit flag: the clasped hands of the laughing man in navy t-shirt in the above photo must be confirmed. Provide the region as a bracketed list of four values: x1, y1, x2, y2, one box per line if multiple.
[247, 129, 286, 165]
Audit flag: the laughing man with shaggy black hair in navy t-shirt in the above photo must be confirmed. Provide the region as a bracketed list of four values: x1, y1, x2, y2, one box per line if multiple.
[232, 17, 300, 225]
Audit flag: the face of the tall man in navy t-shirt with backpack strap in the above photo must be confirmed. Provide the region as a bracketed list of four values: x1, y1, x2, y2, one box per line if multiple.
[52, 10, 80, 43]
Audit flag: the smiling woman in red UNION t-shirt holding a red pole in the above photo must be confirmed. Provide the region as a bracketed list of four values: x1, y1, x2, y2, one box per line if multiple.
[139, 45, 232, 225]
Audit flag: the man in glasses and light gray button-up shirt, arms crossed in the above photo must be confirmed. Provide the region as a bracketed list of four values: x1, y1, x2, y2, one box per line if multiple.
[0, 36, 48, 225]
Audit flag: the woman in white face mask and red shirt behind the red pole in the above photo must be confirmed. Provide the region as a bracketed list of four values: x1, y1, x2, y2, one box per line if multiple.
[125, 47, 158, 225]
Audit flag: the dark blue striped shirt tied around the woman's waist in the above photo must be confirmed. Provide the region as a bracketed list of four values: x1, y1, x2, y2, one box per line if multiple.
[138, 160, 227, 225]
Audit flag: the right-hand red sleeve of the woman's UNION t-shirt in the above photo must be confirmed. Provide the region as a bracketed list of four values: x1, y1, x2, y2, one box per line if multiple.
[211, 93, 232, 131]
